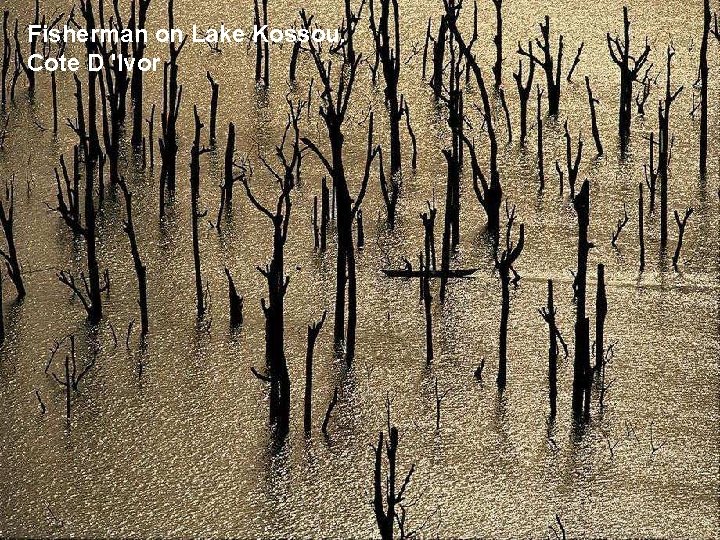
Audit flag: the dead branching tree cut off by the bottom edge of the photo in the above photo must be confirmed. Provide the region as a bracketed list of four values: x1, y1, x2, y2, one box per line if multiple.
[372, 405, 415, 540]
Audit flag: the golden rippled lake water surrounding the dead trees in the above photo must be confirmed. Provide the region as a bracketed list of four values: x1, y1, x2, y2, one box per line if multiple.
[0, 0, 720, 538]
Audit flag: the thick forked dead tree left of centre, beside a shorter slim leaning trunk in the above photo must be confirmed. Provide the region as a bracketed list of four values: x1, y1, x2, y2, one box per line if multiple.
[241, 98, 304, 437]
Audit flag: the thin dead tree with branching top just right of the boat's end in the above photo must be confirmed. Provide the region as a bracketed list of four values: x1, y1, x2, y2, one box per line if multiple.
[495, 203, 525, 390]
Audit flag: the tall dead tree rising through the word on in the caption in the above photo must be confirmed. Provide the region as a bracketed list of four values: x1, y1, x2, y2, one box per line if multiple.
[158, 0, 187, 218]
